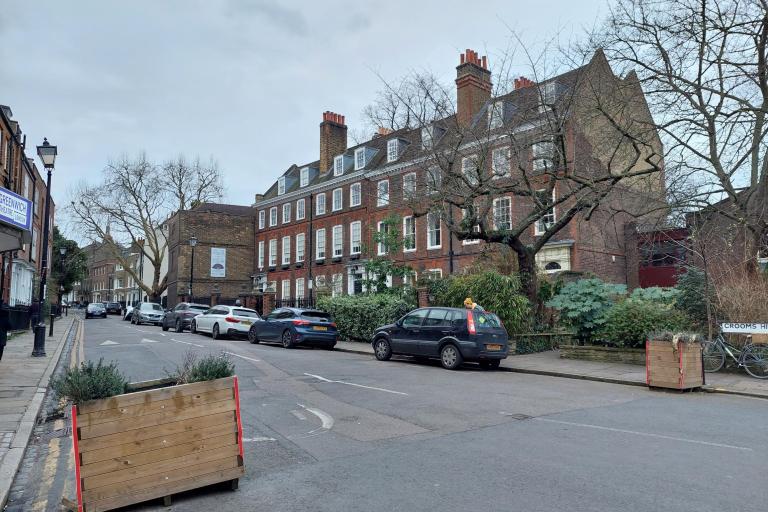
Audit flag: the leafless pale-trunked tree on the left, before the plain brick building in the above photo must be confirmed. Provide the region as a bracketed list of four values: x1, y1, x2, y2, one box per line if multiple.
[69, 154, 222, 298]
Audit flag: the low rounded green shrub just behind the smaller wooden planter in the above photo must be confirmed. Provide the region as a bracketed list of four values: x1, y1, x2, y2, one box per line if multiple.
[599, 298, 687, 347]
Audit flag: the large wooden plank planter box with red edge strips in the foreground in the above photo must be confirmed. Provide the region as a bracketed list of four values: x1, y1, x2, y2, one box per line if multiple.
[72, 377, 245, 512]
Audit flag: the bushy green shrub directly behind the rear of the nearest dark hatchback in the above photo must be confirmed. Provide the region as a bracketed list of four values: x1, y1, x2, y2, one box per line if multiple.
[433, 271, 532, 334]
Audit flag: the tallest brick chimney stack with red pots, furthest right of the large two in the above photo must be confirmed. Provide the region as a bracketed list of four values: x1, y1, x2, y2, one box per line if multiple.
[456, 49, 492, 127]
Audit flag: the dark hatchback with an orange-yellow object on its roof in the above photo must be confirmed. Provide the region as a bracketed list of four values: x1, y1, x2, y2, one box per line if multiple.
[372, 308, 509, 370]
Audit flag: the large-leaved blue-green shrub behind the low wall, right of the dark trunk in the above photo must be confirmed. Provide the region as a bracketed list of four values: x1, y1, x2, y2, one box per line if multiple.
[547, 278, 627, 342]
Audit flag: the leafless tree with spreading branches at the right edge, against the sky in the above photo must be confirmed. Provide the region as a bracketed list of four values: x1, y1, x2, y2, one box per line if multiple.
[592, 0, 768, 268]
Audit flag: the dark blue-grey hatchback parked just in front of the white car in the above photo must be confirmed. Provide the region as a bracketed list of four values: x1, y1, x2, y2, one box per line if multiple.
[248, 308, 339, 350]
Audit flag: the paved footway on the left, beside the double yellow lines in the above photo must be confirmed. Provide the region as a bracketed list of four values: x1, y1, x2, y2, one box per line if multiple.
[0, 315, 78, 508]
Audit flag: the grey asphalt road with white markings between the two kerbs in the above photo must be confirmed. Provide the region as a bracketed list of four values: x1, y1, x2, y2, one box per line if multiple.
[33, 317, 768, 512]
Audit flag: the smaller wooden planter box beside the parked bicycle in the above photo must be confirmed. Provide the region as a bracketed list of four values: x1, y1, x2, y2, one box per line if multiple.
[645, 340, 704, 389]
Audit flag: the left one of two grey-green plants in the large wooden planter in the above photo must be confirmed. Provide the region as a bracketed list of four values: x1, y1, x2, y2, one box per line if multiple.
[52, 359, 128, 404]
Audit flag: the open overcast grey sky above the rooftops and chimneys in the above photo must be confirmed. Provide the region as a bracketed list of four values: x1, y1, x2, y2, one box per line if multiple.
[0, 0, 606, 234]
